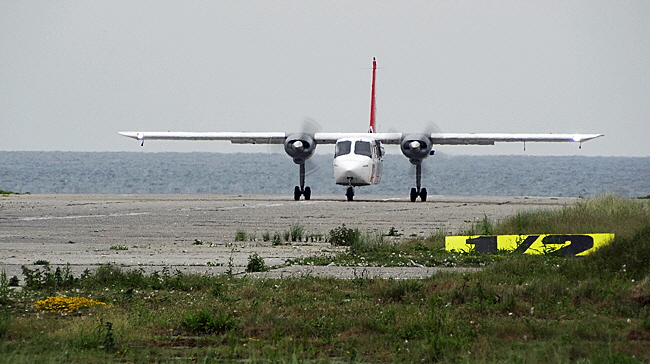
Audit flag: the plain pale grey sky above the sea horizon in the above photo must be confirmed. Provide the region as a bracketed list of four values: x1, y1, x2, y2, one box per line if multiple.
[0, 0, 650, 156]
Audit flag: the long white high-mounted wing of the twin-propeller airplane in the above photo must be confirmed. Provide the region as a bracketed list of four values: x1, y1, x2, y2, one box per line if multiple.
[120, 131, 603, 145]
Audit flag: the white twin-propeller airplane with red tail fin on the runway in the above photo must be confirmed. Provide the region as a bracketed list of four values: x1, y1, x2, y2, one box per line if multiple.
[119, 57, 603, 202]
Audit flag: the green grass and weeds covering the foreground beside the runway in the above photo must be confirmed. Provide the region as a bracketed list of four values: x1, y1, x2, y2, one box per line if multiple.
[0, 196, 650, 363]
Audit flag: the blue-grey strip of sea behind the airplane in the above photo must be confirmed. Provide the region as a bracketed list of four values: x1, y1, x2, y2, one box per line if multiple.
[0, 151, 650, 198]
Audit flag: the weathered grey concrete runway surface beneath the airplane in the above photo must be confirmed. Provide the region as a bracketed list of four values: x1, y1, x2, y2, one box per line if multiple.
[0, 194, 578, 278]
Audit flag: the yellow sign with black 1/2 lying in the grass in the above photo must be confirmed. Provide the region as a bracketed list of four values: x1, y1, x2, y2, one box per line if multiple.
[445, 234, 614, 256]
